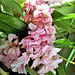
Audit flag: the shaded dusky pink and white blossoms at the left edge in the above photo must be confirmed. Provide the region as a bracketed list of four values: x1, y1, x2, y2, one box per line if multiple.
[0, 34, 20, 68]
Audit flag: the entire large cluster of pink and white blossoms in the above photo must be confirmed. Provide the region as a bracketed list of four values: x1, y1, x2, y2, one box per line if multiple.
[0, 0, 62, 75]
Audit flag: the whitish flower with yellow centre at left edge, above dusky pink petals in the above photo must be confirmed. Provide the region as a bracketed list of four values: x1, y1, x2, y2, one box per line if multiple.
[0, 34, 19, 49]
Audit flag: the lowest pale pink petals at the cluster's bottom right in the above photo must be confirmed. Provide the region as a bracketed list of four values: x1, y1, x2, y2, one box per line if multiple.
[38, 59, 63, 75]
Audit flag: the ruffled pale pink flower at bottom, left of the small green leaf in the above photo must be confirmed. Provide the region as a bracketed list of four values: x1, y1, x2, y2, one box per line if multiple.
[11, 53, 30, 74]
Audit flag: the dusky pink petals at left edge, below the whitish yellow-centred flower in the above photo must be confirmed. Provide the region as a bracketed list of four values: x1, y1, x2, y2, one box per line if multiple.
[0, 47, 20, 68]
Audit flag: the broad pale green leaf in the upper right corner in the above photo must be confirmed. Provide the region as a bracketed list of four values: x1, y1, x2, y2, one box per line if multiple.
[52, 1, 75, 15]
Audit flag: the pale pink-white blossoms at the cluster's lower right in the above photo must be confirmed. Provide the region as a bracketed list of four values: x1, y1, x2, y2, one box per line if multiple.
[31, 48, 63, 75]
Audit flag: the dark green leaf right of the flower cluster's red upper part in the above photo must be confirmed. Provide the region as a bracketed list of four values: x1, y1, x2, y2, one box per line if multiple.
[52, 10, 71, 33]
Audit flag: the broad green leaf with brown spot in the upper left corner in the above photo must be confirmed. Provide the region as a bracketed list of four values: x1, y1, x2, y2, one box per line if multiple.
[0, 0, 23, 16]
